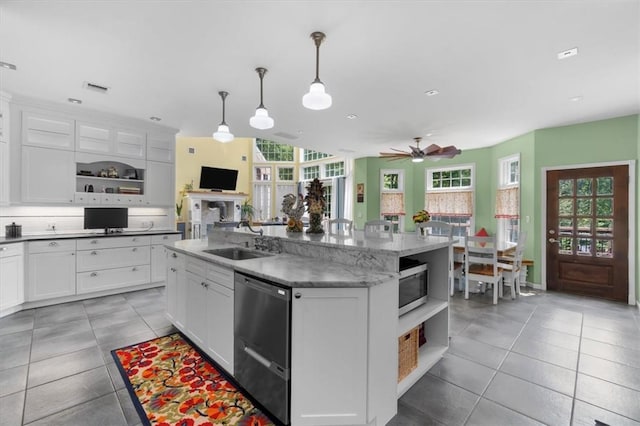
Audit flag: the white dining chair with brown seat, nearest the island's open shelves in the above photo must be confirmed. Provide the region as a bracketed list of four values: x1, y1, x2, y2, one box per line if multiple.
[464, 236, 502, 305]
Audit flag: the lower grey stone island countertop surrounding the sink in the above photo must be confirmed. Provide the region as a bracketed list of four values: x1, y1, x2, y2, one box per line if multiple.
[168, 240, 397, 288]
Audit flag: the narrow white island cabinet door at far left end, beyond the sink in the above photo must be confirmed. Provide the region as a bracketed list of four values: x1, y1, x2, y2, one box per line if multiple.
[166, 250, 187, 333]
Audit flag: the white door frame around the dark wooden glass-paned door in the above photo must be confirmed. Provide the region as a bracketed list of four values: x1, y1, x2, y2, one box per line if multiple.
[539, 160, 640, 305]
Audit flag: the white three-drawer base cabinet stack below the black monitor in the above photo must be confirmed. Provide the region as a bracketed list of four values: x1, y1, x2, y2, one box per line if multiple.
[77, 236, 151, 294]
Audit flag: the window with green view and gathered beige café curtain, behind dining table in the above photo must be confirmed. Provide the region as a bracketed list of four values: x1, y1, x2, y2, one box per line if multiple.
[424, 165, 474, 237]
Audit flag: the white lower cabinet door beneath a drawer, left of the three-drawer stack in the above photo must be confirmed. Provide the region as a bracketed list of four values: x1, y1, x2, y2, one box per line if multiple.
[27, 243, 76, 302]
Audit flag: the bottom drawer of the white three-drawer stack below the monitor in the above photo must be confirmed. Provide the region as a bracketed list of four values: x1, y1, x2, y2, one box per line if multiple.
[76, 265, 150, 294]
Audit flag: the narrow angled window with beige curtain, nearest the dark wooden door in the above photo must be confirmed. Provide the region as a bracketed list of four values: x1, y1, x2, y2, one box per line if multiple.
[495, 154, 520, 244]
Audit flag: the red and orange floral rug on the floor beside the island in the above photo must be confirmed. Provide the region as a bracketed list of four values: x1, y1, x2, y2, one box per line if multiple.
[111, 333, 274, 426]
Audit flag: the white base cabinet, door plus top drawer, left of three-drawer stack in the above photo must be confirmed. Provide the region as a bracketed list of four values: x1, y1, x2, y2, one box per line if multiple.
[27, 240, 76, 302]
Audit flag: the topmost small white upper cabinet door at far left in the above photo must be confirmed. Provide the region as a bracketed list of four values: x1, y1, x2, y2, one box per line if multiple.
[22, 110, 75, 151]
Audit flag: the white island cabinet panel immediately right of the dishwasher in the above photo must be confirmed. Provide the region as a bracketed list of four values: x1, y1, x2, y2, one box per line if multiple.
[291, 288, 368, 426]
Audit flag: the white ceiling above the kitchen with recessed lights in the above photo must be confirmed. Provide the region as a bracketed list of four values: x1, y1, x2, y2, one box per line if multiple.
[0, 0, 640, 157]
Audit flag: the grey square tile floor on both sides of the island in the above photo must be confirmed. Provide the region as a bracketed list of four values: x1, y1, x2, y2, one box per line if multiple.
[0, 289, 640, 426]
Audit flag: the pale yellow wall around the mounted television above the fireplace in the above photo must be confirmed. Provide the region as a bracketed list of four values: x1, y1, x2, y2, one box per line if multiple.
[176, 137, 253, 215]
